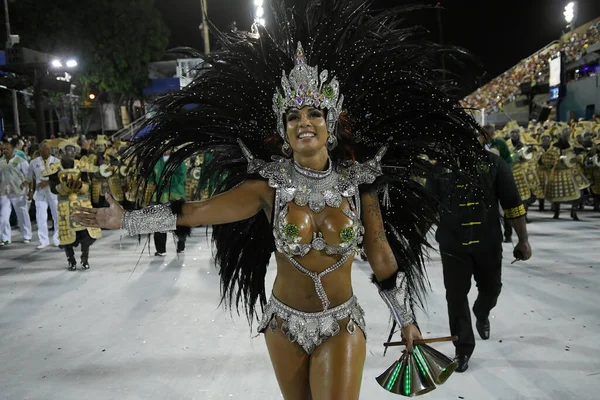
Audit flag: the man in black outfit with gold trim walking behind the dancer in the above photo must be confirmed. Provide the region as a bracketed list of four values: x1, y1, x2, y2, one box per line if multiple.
[427, 134, 531, 372]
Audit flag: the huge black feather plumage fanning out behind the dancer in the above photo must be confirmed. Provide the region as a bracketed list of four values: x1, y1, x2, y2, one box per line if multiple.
[126, 0, 485, 320]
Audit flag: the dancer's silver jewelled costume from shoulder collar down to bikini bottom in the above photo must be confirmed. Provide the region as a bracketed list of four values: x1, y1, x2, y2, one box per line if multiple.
[240, 143, 386, 354]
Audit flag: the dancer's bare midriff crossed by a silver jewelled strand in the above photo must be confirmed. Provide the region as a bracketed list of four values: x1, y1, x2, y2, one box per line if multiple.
[273, 250, 354, 312]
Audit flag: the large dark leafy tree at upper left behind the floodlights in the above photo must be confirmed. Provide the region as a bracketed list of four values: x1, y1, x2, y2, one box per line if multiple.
[2, 0, 169, 134]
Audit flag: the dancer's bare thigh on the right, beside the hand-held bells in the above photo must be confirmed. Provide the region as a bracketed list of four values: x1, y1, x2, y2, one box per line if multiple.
[310, 319, 367, 400]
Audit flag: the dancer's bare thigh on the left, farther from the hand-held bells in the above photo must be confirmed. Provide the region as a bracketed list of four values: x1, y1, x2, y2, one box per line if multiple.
[265, 318, 312, 400]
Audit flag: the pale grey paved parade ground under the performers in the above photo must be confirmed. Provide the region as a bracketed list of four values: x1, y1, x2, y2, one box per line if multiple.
[0, 208, 600, 400]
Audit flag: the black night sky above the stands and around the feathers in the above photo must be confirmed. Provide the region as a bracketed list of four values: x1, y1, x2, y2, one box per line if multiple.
[158, 0, 600, 80]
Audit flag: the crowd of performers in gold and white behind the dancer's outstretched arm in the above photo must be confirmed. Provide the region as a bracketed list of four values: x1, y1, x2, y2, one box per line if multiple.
[0, 135, 220, 271]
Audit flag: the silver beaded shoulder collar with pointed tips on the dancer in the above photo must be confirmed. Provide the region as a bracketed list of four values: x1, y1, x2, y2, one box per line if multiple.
[238, 139, 388, 213]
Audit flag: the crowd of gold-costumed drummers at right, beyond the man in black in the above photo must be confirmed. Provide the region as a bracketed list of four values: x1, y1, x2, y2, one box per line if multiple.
[489, 120, 600, 227]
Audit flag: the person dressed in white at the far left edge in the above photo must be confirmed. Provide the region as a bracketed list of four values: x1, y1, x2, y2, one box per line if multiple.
[0, 139, 31, 246]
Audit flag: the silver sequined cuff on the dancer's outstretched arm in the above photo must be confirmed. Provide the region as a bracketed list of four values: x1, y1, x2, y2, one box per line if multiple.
[121, 203, 177, 236]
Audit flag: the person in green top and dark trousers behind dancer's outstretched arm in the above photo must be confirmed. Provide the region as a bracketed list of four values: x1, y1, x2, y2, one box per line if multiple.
[150, 150, 187, 257]
